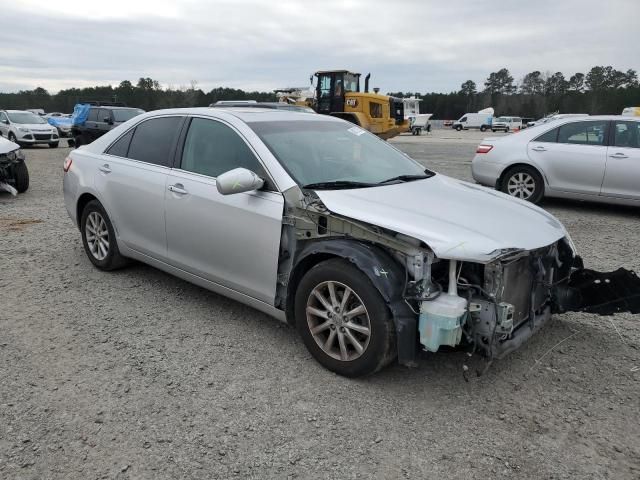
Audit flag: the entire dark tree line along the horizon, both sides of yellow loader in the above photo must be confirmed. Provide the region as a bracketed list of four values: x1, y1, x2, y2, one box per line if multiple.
[0, 66, 640, 119]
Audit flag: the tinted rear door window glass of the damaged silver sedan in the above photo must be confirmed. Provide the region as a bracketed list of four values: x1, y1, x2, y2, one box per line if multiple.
[126, 117, 183, 167]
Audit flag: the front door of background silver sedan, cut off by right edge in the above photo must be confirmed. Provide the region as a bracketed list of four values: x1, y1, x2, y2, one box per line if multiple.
[602, 120, 640, 200]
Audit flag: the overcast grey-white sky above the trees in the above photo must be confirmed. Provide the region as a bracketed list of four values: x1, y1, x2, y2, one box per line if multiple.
[0, 0, 640, 92]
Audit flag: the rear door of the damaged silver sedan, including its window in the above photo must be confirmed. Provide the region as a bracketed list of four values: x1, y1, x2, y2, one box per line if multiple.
[95, 116, 184, 261]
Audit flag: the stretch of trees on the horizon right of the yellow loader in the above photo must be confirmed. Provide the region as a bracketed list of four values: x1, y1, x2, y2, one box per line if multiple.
[389, 66, 640, 119]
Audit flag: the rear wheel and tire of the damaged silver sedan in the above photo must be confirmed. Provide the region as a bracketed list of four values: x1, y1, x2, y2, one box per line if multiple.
[80, 200, 127, 271]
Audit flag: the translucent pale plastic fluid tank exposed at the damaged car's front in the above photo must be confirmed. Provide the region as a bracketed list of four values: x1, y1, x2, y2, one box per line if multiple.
[418, 293, 467, 352]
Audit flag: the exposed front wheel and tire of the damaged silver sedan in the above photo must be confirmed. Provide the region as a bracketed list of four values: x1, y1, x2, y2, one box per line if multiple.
[295, 259, 396, 377]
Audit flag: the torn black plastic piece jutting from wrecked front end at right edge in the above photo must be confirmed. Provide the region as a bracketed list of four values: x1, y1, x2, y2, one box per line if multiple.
[556, 268, 640, 315]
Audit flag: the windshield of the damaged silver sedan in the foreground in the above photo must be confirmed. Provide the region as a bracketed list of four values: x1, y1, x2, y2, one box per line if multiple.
[249, 120, 433, 188]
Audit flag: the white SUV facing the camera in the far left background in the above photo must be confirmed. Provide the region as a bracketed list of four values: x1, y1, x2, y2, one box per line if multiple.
[0, 110, 60, 148]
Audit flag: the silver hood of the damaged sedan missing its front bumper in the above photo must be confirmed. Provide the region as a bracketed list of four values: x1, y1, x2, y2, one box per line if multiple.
[316, 175, 567, 263]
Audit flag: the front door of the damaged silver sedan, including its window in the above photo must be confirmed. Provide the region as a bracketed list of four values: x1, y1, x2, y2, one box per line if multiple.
[165, 117, 284, 305]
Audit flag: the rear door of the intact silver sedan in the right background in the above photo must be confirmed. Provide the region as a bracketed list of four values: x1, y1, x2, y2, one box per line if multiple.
[527, 120, 609, 195]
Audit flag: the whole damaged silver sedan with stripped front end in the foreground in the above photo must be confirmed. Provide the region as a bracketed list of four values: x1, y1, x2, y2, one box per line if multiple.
[64, 109, 640, 376]
